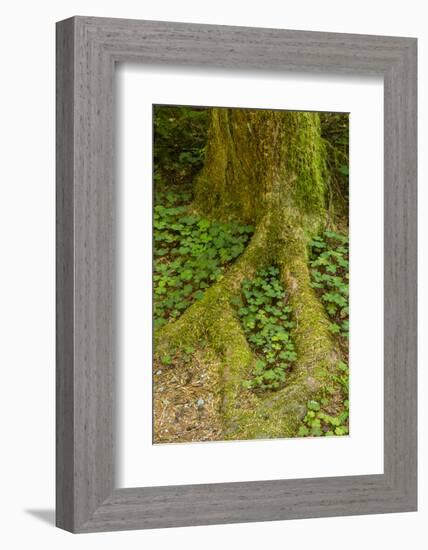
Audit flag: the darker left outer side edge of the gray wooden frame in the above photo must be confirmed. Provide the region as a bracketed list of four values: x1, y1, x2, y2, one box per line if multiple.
[56, 18, 74, 530]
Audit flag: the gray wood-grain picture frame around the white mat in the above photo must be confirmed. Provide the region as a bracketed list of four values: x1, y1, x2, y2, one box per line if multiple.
[56, 17, 417, 533]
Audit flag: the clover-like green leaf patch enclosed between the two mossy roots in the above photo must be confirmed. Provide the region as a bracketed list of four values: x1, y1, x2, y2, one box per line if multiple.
[235, 266, 296, 390]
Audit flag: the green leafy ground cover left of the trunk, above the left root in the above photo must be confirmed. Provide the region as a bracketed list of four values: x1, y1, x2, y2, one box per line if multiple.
[153, 188, 254, 328]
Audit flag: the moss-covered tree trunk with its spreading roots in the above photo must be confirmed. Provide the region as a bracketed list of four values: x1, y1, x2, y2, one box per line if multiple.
[156, 109, 339, 439]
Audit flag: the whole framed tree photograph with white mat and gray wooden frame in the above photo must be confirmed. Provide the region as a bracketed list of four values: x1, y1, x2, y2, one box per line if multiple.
[57, 17, 417, 533]
